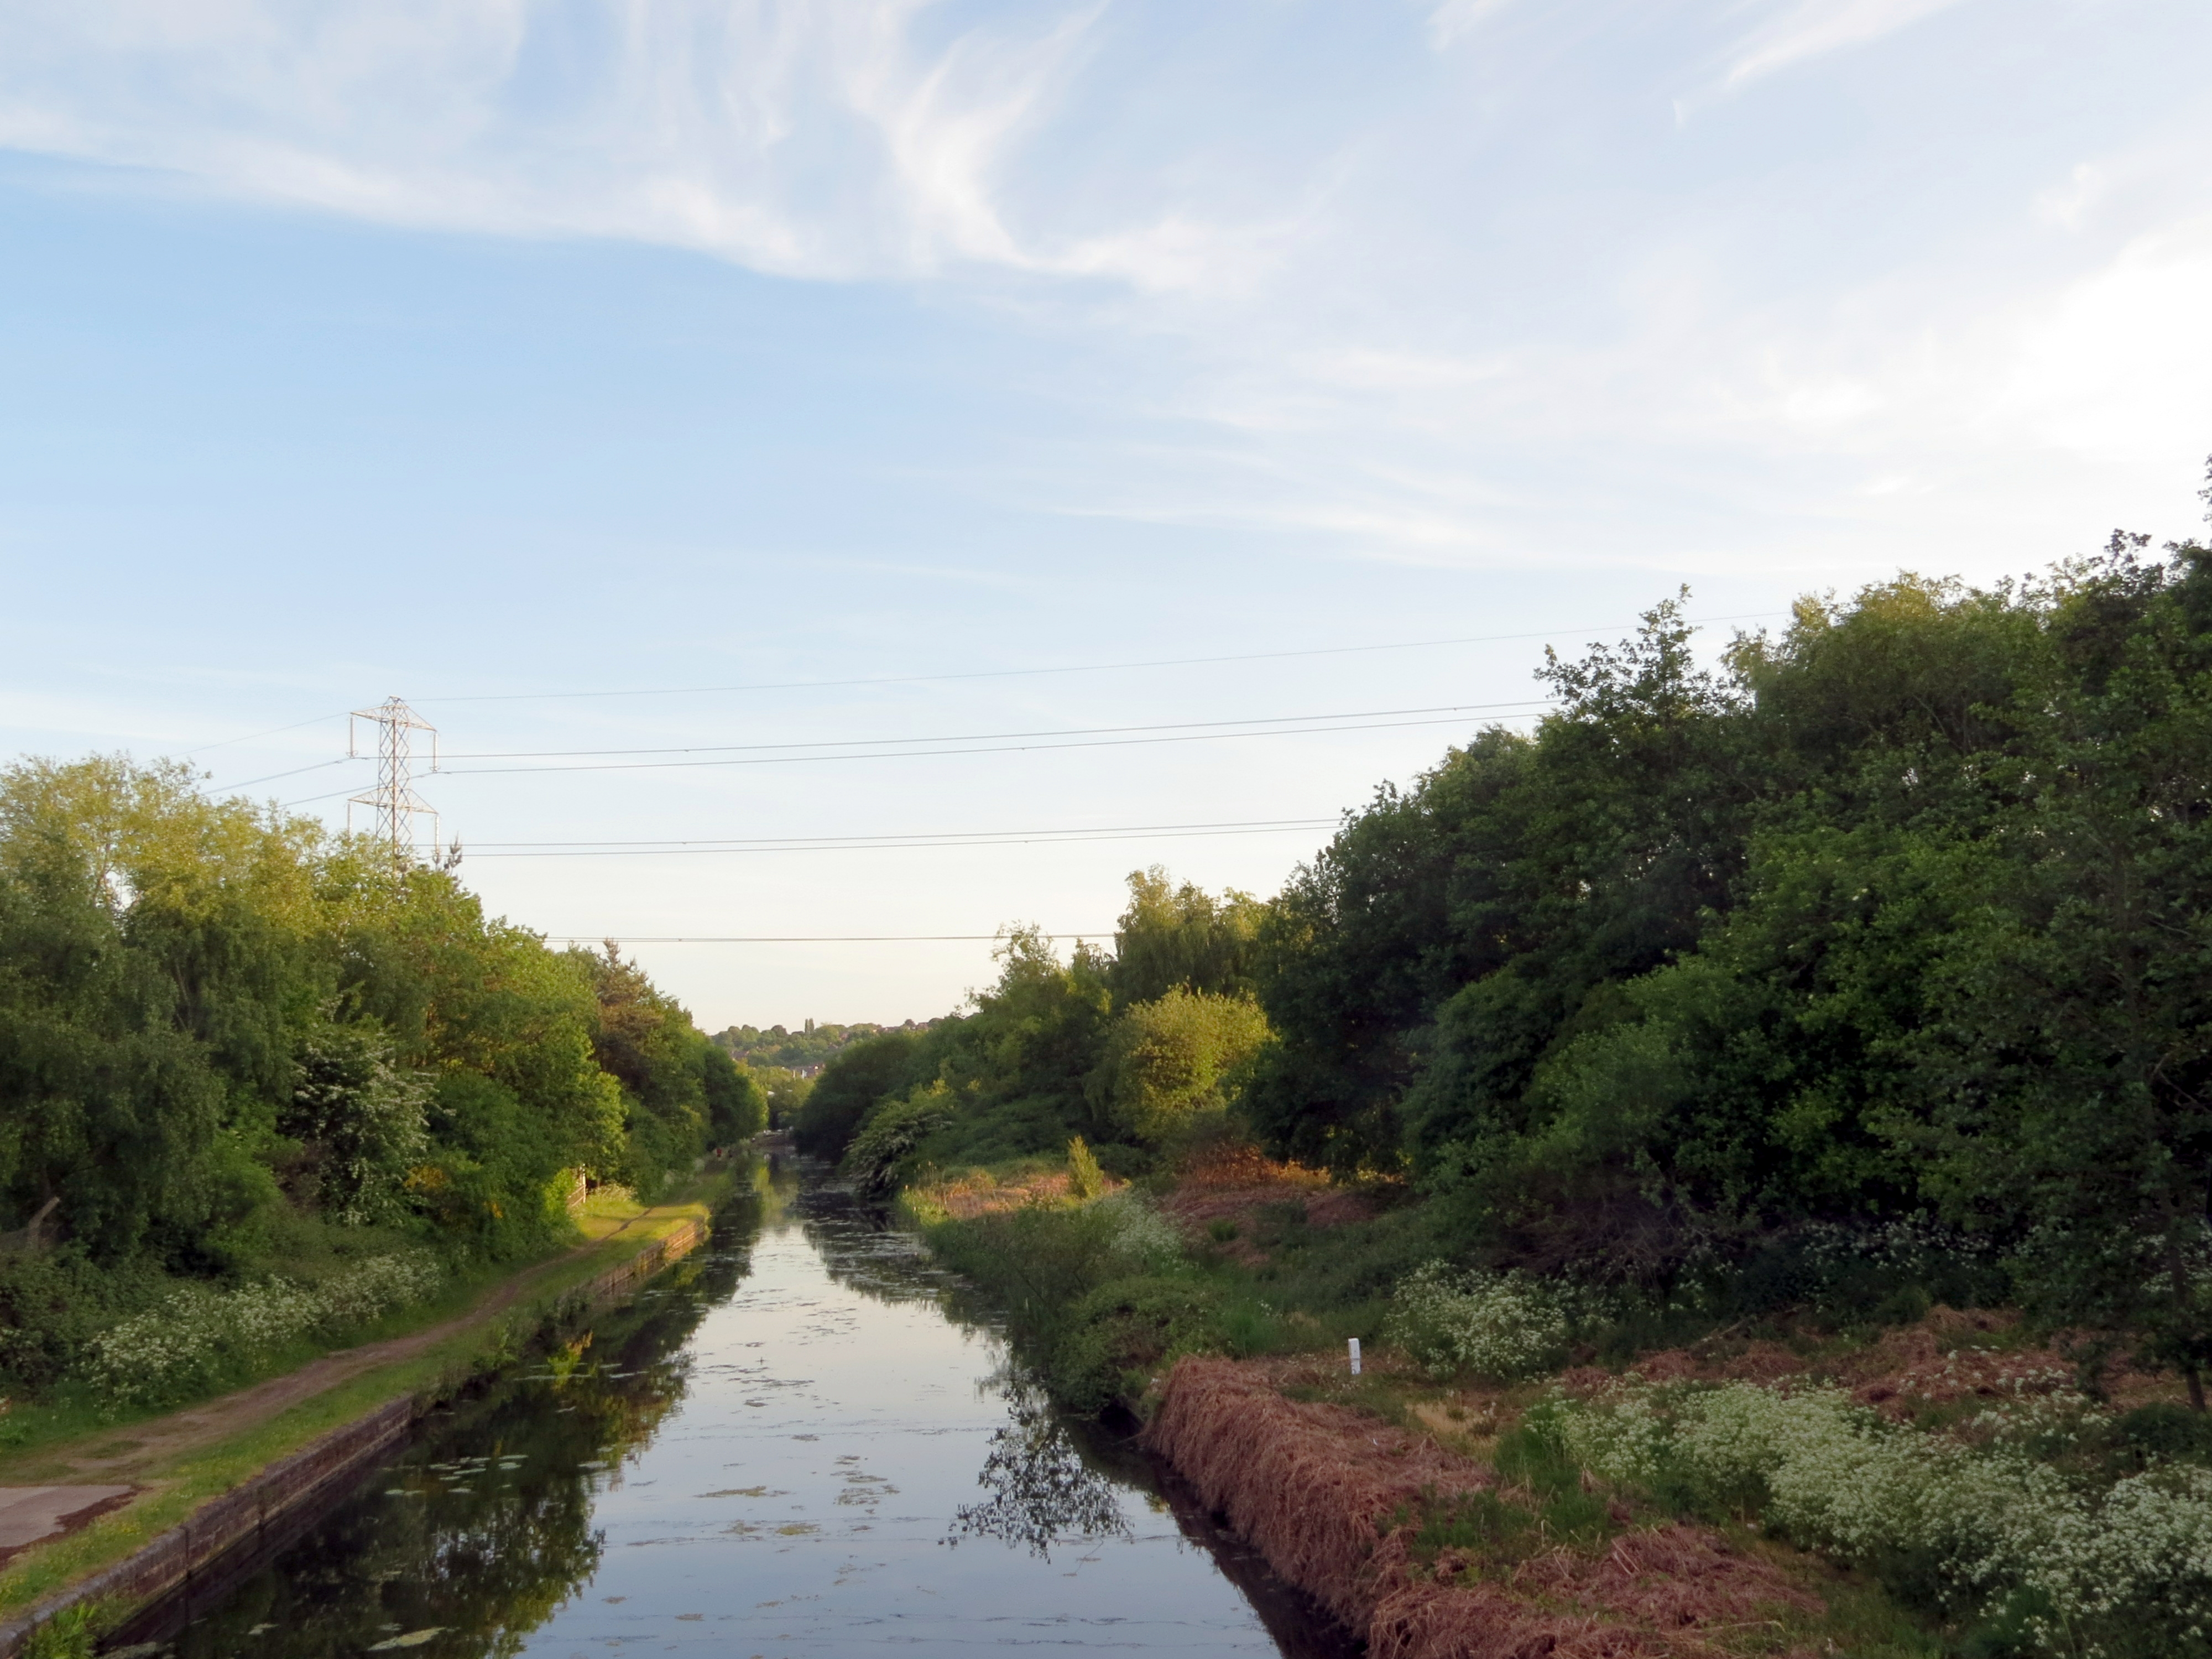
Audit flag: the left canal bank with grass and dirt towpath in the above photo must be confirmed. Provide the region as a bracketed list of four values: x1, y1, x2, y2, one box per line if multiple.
[0, 1175, 732, 1659]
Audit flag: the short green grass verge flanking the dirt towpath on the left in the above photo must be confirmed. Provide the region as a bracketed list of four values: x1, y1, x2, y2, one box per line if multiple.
[0, 1175, 732, 1619]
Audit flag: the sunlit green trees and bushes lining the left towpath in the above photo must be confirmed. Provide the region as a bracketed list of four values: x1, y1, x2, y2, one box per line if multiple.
[0, 759, 765, 1449]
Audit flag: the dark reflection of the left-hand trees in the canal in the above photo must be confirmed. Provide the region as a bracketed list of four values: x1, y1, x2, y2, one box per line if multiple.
[150, 1199, 759, 1659]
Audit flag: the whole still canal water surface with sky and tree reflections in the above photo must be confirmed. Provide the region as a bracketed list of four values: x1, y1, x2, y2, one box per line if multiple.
[111, 1166, 1352, 1659]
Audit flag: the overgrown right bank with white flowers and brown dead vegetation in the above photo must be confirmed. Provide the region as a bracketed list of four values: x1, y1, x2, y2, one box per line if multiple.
[902, 1166, 2212, 1659]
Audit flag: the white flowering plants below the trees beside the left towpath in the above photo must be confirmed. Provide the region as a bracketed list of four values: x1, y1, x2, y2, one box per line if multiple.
[77, 1250, 442, 1407]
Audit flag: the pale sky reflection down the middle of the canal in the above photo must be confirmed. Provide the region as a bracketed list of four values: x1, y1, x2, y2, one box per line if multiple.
[549, 1206, 1274, 1659]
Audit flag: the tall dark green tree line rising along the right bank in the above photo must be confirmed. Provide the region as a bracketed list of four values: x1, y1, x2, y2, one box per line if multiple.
[799, 535, 2212, 1391]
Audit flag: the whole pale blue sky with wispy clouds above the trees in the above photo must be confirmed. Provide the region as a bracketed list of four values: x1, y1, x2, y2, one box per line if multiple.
[0, 0, 2212, 1031]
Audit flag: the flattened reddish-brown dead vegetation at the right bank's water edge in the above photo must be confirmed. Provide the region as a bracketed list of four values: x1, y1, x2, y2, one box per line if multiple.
[1146, 1358, 1820, 1659]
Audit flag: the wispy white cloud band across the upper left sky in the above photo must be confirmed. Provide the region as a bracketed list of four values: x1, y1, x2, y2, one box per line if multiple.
[0, 0, 1265, 285]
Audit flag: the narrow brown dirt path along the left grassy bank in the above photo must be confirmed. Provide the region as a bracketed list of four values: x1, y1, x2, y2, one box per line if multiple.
[40, 1206, 668, 1484]
